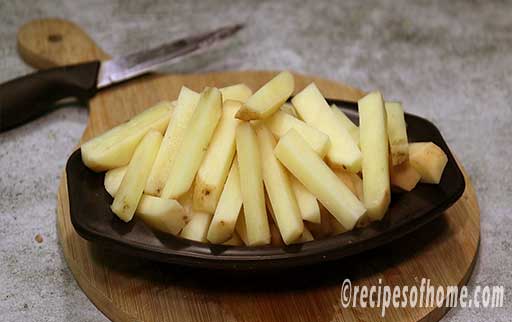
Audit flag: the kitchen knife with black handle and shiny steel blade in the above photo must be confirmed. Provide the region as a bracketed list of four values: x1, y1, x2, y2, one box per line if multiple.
[0, 24, 243, 132]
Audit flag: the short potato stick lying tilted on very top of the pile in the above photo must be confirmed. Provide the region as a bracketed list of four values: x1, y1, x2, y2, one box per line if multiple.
[236, 72, 295, 121]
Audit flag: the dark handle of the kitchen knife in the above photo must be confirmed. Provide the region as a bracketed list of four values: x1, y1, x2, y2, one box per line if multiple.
[0, 61, 100, 132]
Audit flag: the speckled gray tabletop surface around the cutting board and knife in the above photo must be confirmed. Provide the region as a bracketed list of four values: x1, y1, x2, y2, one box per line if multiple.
[0, 0, 512, 321]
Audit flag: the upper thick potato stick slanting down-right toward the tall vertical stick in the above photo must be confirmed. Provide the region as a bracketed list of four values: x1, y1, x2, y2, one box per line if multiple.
[292, 83, 362, 173]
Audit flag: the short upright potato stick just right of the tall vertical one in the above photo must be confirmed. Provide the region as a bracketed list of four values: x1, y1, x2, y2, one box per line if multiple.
[384, 102, 409, 166]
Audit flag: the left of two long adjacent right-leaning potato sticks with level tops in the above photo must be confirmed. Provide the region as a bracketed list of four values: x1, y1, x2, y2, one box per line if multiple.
[144, 86, 199, 196]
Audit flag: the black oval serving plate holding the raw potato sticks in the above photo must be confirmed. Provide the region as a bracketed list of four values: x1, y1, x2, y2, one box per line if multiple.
[66, 100, 465, 271]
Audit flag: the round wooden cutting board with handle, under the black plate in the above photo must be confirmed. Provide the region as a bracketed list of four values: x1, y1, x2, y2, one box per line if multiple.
[18, 19, 480, 322]
